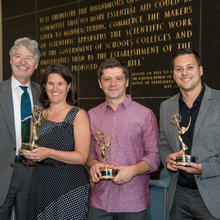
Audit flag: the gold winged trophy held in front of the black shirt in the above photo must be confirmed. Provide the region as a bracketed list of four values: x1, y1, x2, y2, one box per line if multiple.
[170, 114, 196, 167]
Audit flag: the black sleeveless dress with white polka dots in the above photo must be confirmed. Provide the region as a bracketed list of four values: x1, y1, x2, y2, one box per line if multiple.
[27, 107, 91, 220]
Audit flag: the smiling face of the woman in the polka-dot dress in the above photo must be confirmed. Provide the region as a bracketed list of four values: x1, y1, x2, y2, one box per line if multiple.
[46, 73, 71, 103]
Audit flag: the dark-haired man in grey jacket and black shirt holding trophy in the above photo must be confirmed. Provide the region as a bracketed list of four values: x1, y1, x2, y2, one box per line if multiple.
[159, 49, 220, 220]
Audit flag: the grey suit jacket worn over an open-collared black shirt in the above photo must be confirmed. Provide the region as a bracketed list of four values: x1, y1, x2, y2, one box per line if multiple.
[159, 85, 220, 218]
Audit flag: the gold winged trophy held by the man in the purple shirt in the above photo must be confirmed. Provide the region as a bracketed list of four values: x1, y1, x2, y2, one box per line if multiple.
[94, 130, 117, 180]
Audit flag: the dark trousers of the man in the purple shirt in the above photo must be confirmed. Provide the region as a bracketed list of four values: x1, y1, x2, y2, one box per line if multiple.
[87, 206, 147, 220]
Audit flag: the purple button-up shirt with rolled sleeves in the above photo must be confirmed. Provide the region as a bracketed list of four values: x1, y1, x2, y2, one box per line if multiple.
[88, 96, 160, 212]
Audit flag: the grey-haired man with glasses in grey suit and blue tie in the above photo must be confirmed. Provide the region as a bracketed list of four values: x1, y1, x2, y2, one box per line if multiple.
[0, 37, 40, 220]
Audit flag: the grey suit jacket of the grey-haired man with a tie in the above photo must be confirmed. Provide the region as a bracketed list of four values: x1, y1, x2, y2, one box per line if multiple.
[0, 78, 39, 206]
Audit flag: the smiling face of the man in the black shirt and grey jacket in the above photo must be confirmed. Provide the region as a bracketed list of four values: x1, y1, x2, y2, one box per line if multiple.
[173, 54, 203, 92]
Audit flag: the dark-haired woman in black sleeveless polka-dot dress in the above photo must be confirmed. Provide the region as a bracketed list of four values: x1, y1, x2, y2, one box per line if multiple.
[24, 64, 91, 220]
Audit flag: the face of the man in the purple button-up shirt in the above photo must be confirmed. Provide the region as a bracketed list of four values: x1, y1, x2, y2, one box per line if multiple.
[99, 67, 128, 102]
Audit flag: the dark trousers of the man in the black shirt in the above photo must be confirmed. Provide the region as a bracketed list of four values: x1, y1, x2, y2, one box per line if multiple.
[170, 184, 220, 220]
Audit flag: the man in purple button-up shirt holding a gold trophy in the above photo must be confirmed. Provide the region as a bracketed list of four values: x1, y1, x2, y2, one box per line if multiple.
[87, 58, 160, 220]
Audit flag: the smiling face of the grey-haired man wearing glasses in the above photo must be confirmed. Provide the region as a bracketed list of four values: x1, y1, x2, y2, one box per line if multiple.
[10, 45, 38, 83]
